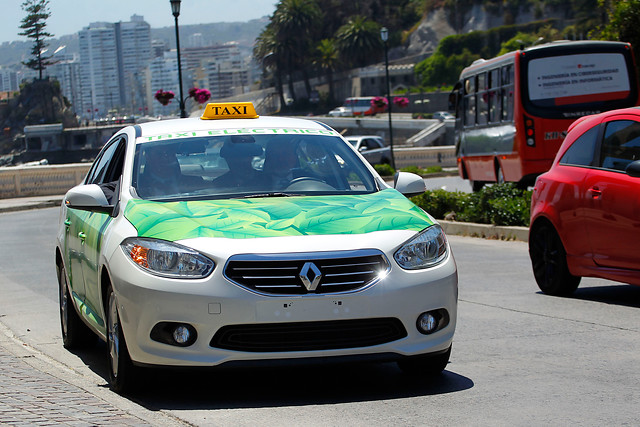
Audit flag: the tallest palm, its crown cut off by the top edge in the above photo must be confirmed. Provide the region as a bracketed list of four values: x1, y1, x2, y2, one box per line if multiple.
[271, 0, 322, 100]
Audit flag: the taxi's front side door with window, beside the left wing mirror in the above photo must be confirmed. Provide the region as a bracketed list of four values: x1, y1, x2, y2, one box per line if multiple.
[79, 137, 126, 326]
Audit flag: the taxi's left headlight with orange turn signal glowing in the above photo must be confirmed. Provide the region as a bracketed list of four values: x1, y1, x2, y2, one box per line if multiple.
[120, 237, 215, 279]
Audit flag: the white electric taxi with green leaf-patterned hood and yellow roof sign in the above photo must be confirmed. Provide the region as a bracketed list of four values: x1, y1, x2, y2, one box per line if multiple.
[55, 103, 457, 392]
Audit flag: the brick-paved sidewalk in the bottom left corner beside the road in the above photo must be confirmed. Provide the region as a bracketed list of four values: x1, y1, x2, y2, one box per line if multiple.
[0, 339, 152, 426]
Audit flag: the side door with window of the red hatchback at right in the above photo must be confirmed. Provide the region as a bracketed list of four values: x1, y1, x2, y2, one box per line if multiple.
[582, 116, 640, 270]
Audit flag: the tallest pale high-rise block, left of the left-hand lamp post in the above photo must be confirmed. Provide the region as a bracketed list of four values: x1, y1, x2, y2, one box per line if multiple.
[77, 15, 151, 117]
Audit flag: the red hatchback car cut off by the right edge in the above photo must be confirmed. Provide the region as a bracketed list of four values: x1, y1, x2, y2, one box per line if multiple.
[529, 108, 640, 295]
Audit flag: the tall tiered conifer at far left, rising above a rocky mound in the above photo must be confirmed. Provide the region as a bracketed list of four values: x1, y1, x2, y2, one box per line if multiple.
[18, 0, 53, 80]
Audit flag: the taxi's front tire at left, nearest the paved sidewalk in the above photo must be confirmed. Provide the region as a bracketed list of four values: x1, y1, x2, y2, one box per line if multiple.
[105, 285, 136, 394]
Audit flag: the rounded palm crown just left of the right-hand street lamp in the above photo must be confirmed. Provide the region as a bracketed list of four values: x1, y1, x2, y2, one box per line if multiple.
[336, 15, 383, 67]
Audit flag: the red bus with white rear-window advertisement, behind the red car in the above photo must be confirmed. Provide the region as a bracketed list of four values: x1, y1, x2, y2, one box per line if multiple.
[451, 41, 640, 191]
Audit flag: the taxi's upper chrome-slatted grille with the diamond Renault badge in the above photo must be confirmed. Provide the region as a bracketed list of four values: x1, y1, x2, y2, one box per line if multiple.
[224, 249, 389, 295]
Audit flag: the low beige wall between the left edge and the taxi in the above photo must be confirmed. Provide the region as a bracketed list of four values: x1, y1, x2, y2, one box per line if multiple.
[0, 163, 91, 199]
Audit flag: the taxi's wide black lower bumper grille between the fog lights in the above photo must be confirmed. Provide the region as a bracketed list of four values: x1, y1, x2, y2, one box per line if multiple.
[210, 318, 407, 352]
